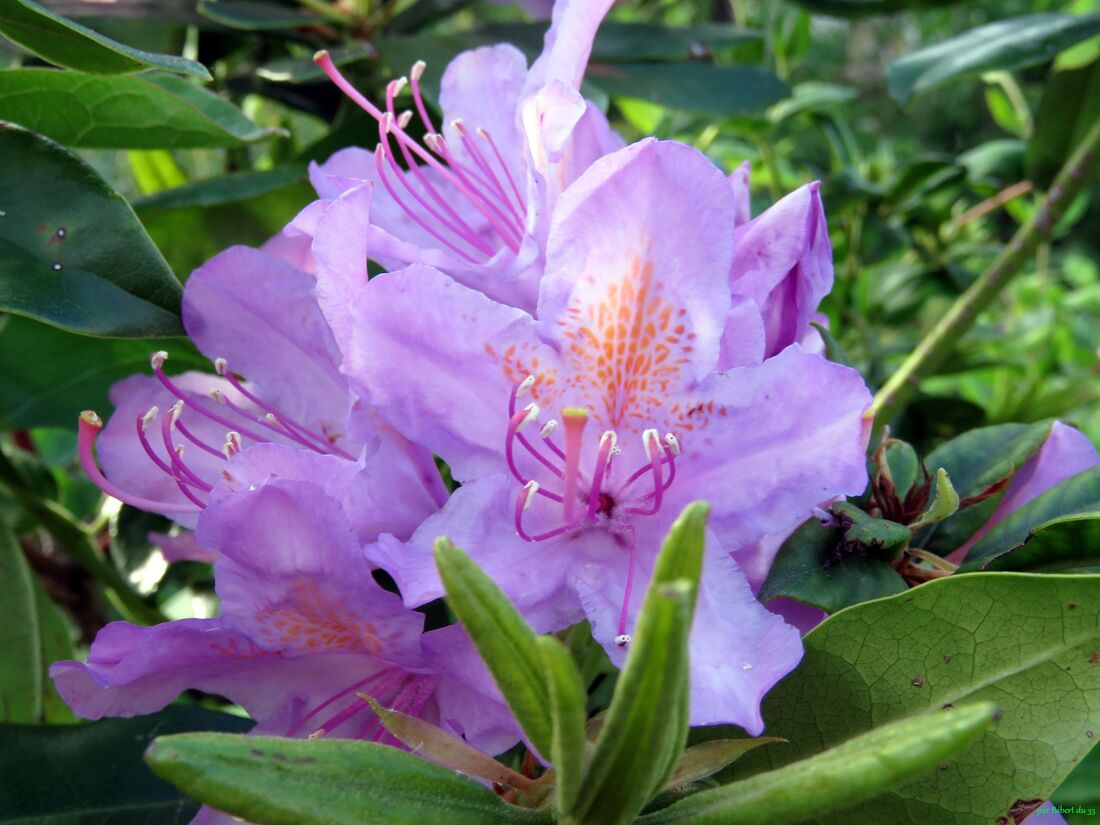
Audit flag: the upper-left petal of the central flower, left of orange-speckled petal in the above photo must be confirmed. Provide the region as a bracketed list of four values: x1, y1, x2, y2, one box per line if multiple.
[344, 266, 557, 480]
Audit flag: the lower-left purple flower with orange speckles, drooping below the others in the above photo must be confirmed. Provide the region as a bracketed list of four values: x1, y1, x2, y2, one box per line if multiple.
[51, 455, 518, 752]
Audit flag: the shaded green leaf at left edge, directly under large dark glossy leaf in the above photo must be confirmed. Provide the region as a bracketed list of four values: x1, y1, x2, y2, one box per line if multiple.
[0, 316, 210, 429]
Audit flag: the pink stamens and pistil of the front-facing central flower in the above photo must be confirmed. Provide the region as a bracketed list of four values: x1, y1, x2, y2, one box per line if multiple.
[505, 375, 680, 646]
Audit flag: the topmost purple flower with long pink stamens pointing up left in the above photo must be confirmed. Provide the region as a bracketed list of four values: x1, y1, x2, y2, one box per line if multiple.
[310, 0, 623, 309]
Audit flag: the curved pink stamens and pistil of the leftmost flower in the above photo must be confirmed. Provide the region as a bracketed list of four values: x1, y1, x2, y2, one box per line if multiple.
[78, 352, 355, 513]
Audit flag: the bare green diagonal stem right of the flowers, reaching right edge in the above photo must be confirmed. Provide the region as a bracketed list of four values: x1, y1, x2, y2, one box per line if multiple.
[871, 122, 1100, 428]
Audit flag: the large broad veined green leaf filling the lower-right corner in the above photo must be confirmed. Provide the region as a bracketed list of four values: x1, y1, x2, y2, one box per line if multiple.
[711, 573, 1100, 825]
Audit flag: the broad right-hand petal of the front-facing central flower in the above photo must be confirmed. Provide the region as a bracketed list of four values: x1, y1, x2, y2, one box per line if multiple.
[666, 344, 871, 548]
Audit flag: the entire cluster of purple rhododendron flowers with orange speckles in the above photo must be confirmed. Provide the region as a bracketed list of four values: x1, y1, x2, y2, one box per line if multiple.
[52, 0, 897, 815]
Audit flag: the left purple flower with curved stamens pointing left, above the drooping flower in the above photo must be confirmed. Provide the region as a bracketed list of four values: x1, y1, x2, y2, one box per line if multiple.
[80, 205, 447, 550]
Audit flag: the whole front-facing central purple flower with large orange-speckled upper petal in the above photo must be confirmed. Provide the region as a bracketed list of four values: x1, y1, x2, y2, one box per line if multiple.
[343, 140, 869, 733]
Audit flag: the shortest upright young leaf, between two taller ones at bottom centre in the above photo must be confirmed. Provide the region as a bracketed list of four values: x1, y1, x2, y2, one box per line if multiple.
[538, 636, 587, 812]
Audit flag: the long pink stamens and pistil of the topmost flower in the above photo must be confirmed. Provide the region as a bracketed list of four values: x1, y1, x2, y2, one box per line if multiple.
[314, 52, 527, 264]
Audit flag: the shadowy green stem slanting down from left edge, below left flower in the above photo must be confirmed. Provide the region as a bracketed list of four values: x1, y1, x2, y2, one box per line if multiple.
[0, 450, 167, 625]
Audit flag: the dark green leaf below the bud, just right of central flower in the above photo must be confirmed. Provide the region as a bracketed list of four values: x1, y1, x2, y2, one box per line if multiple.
[758, 518, 909, 613]
